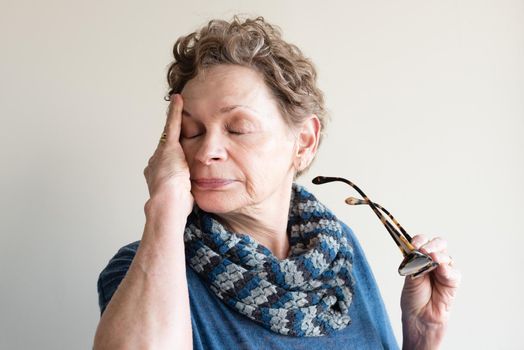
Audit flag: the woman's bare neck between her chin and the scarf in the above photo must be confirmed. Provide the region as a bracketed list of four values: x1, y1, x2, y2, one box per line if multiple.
[215, 182, 291, 260]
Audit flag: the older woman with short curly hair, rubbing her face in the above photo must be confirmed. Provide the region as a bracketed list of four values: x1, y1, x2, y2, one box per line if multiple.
[94, 16, 460, 349]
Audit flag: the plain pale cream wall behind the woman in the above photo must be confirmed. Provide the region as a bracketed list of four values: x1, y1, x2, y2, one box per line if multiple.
[0, 0, 524, 349]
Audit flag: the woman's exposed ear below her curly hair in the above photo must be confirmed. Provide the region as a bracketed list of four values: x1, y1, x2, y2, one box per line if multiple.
[293, 114, 321, 171]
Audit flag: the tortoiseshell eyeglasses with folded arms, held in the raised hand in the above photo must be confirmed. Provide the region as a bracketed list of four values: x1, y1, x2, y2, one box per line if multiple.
[312, 176, 438, 278]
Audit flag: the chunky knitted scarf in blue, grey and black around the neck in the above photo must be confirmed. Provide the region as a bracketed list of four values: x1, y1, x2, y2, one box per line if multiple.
[184, 184, 353, 337]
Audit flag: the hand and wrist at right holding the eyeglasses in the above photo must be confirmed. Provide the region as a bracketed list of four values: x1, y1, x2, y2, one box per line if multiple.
[400, 235, 461, 349]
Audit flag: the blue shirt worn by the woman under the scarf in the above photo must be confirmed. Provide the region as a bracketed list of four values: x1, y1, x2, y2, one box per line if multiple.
[98, 223, 398, 350]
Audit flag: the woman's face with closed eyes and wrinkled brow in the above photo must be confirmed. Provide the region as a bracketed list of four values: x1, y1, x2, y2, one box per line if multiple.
[180, 65, 296, 213]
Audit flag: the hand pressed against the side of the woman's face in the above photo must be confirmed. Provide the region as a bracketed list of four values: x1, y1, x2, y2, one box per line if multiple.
[144, 94, 194, 215]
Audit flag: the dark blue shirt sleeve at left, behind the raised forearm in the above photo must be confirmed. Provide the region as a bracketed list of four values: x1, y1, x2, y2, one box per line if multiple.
[97, 241, 140, 314]
